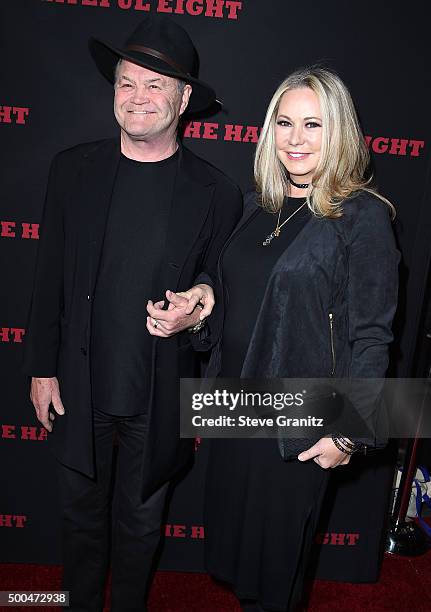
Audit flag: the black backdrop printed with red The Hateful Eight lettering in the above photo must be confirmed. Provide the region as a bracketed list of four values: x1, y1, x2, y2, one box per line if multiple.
[0, 0, 431, 581]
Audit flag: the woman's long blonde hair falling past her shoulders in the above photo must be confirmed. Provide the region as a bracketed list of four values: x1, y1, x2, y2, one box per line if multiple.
[254, 67, 395, 218]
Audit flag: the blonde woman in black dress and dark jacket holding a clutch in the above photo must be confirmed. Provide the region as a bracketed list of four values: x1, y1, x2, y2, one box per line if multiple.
[205, 68, 399, 612]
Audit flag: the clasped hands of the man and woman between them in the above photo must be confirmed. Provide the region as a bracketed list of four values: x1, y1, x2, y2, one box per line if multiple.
[147, 283, 214, 338]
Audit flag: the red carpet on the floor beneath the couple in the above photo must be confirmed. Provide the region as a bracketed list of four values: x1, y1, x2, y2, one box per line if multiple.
[0, 551, 431, 612]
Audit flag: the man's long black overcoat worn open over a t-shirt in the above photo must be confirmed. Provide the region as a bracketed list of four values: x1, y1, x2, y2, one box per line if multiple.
[25, 139, 242, 496]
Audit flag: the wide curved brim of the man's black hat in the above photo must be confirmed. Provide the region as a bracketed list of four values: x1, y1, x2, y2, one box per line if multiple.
[88, 38, 218, 114]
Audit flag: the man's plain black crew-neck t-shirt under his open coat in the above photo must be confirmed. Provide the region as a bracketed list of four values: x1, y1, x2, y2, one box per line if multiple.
[90, 152, 178, 416]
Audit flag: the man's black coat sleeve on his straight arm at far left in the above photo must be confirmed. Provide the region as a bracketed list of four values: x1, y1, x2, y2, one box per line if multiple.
[23, 156, 64, 378]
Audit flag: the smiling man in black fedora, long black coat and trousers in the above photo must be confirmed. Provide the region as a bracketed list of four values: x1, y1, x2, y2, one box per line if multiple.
[25, 15, 242, 612]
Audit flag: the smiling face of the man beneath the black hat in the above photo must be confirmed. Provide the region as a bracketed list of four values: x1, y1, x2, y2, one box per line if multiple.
[114, 60, 192, 142]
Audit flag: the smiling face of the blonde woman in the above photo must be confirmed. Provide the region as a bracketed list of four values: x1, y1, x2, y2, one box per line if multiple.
[275, 87, 322, 183]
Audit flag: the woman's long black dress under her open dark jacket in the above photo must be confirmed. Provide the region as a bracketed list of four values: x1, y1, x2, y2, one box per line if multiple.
[205, 198, 328, 611]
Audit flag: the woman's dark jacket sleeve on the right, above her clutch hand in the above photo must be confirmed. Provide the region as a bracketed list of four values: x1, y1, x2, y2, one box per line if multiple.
[348, 197, 400, 447]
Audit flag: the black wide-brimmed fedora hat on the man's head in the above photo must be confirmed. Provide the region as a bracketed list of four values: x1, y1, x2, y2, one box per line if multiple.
[89, 15, 216, 113]
